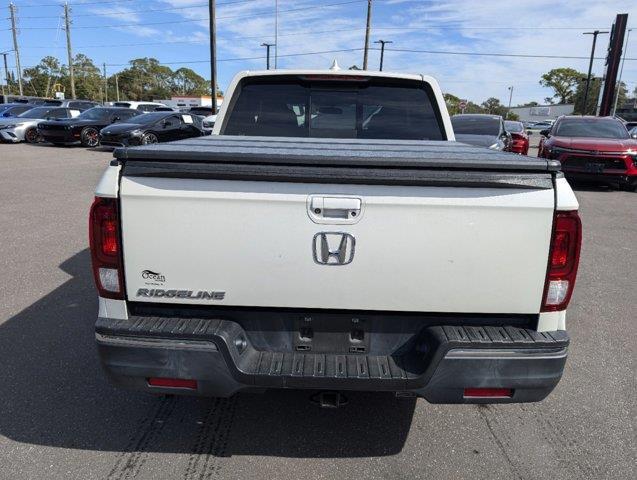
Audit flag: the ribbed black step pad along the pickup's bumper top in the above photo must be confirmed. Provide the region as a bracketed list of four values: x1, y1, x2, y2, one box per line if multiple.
[96, 317, 569, 390]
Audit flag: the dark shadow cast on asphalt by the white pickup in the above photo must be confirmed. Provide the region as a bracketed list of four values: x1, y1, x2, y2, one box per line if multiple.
[0, 250, 416, 457]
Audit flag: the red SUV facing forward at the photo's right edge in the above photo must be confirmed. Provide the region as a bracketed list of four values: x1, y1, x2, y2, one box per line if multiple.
[538, 116, 637, 190]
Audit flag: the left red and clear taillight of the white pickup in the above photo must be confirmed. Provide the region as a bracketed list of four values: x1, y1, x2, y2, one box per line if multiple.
[89, 197, 124, 300]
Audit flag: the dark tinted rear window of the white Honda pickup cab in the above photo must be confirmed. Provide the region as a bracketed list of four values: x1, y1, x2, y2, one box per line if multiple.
[222, 77, 444, 140]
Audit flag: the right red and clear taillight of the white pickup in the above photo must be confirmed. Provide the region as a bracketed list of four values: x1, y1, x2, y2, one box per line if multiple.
[542, 211, 582, 312]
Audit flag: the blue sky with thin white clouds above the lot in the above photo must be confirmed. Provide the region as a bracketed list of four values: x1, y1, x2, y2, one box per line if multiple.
[0, 0, 637, 105]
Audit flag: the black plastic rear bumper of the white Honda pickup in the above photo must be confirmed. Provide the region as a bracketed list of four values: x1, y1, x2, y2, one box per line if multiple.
[96, 317, 569, 403]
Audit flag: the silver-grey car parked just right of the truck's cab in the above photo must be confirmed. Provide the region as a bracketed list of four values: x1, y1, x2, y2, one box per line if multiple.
[451, 113, 511, 151]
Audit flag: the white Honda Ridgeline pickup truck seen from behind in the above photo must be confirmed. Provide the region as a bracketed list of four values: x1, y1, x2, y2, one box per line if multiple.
[90, 70, 581, 403]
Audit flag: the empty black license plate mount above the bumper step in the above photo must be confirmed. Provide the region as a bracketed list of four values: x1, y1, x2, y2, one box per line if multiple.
[293, 315, 371, 354]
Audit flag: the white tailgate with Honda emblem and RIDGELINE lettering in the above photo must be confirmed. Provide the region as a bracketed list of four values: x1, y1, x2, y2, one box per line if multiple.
[120, 175, 554, 314]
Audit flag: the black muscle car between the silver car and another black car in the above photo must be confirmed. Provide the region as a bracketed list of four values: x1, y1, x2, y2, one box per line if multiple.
[38, 107, 139, 147]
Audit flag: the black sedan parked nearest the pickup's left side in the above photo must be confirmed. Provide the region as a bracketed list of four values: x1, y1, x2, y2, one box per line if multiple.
[100, 112, 204, 147]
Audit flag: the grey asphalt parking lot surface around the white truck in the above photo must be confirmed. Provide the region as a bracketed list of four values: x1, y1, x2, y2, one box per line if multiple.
[0, 145, 637, 480]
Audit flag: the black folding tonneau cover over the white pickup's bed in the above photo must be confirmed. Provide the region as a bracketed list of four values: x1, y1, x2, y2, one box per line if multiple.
[114, 135, 560, 188]
